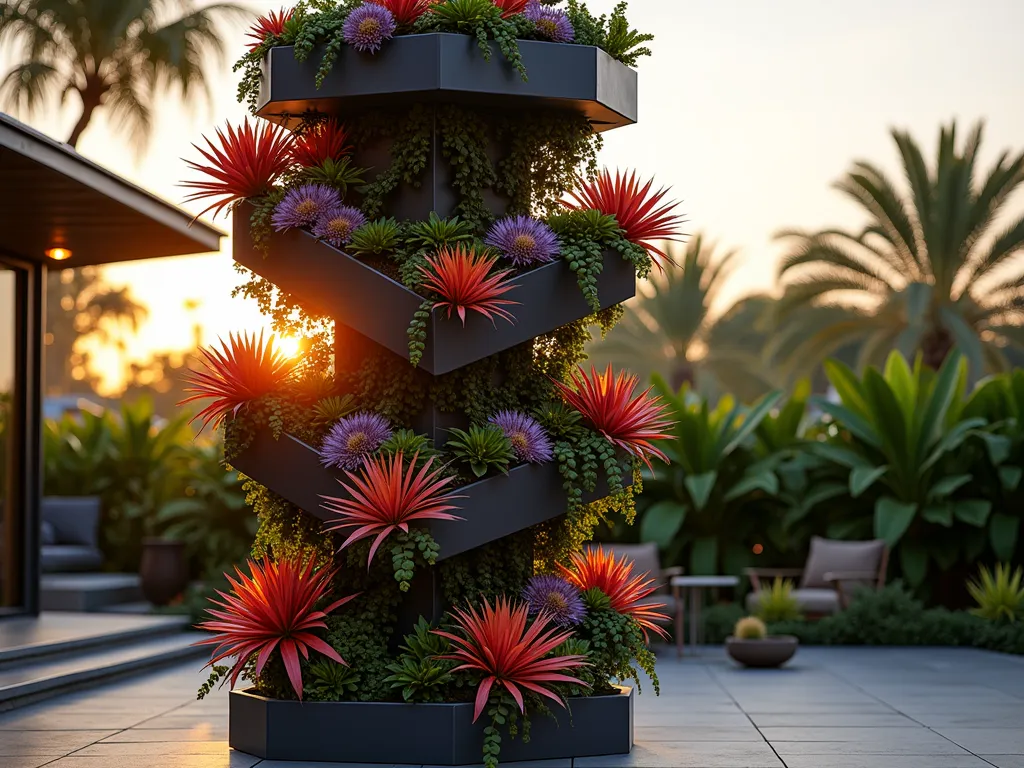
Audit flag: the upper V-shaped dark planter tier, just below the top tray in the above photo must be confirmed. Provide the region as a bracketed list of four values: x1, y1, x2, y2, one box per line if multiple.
[232, 211, 636, 376]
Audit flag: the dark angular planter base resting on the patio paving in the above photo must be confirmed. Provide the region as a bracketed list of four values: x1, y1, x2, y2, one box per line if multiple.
[228, 688, 633, 765]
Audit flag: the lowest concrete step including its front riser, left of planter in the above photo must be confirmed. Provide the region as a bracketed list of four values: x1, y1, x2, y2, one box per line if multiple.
[0, 632, 210, 712]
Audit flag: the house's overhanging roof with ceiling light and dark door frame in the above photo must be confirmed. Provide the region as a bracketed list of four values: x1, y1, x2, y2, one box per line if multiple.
[0, 114, 222, 616]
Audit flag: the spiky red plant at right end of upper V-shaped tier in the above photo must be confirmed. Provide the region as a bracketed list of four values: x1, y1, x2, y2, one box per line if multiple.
[562, 168, 683, 269]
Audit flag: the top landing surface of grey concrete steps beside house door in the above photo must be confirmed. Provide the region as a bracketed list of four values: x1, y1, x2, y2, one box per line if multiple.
[0, 612, 188, 671]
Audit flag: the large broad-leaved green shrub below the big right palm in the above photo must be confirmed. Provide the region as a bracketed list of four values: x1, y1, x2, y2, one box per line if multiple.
[808, 352, 992, 587]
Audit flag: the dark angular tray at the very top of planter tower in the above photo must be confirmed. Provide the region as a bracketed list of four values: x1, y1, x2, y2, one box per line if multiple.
[257, 33, 637, 131]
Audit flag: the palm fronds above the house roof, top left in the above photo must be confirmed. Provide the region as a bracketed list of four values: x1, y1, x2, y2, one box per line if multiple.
[0, 0, 248, 148]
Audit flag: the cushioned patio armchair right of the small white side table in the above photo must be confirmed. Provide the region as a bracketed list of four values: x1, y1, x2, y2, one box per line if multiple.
[743, 536, 889, 616]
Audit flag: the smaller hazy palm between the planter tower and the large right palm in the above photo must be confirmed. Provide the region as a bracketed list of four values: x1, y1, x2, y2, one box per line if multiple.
[590, 234, 786, 399]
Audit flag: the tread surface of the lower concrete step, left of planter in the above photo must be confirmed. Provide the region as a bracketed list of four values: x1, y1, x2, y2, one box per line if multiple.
[0, 632, 206, 700]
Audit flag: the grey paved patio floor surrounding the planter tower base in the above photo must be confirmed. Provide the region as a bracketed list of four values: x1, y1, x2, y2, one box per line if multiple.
[0, 648, 1024, 768]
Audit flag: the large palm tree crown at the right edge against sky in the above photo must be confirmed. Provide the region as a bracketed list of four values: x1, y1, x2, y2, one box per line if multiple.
[778, 122, 1024, 376]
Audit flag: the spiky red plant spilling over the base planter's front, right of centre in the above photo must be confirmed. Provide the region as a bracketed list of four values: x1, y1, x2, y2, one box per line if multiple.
[433, 597, 589, 723]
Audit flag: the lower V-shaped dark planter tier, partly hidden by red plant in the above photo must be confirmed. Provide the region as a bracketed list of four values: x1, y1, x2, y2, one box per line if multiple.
[231, 430, 632, 560]
